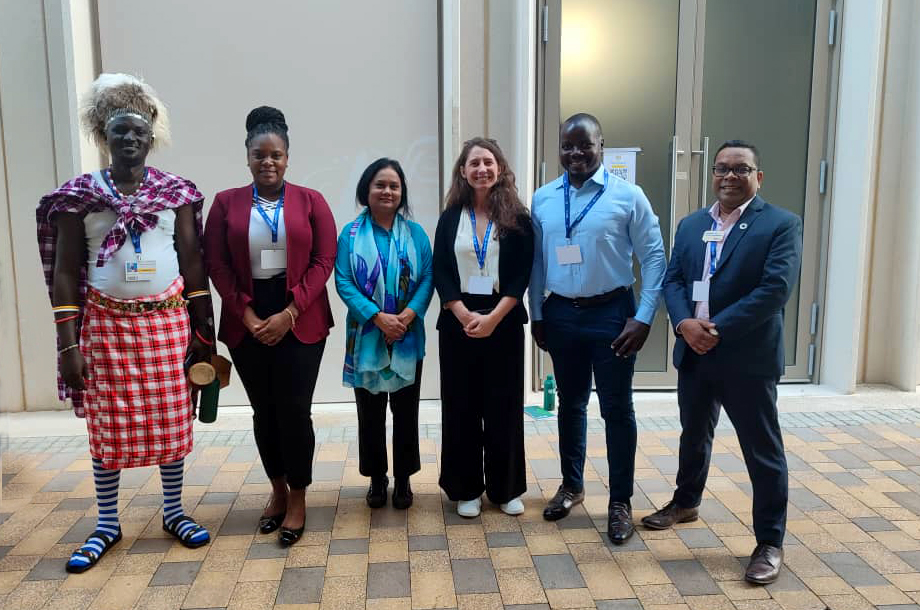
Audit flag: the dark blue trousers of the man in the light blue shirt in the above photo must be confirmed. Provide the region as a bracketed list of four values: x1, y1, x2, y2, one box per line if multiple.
[543, 290, 636, 502]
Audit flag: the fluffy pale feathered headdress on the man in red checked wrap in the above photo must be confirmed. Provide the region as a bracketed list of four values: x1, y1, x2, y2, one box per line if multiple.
[80, 74, 169, 152]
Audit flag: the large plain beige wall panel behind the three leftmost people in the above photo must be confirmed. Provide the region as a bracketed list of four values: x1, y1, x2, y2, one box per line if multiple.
[98, 0, 439, 404]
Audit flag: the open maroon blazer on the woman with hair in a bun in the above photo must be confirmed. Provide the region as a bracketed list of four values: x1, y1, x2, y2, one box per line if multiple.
[204, 182, 337, 347]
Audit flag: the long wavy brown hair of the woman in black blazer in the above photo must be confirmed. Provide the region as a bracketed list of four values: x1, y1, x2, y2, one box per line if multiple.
[444, 137, 530, 235]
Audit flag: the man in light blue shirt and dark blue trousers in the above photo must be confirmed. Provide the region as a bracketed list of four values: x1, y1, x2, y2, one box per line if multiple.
[530, 114, 666, 544]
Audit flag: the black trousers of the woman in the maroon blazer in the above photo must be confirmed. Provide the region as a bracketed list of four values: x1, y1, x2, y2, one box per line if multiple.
[230, 278, 326, 489]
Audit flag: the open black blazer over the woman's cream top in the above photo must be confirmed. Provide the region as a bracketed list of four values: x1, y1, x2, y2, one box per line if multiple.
[431, 205, 534, 329]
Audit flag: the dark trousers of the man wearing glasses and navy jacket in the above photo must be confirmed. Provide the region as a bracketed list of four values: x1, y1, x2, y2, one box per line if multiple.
[674, 354, 789, 546]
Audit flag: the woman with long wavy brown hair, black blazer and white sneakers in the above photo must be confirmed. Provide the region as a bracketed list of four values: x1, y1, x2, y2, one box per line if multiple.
[432, 138, 533, 517]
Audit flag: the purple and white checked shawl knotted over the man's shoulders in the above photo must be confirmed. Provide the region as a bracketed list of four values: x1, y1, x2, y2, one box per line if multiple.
[35, 167, 204, 417]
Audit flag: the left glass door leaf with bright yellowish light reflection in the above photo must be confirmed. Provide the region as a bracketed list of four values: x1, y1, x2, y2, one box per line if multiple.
[534, 0, 697, 388]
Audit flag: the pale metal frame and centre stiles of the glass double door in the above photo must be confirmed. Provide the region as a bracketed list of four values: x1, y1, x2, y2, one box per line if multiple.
[531, 0, 842, 391]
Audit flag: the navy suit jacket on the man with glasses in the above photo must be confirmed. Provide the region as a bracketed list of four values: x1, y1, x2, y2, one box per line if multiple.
[663, 196, 802, 378]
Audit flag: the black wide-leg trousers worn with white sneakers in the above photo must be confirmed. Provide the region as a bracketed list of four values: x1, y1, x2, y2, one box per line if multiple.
[438, 304, 527, 504]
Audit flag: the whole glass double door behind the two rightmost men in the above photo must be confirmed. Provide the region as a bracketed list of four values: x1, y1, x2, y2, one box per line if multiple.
[533, 0, 833, 389]
